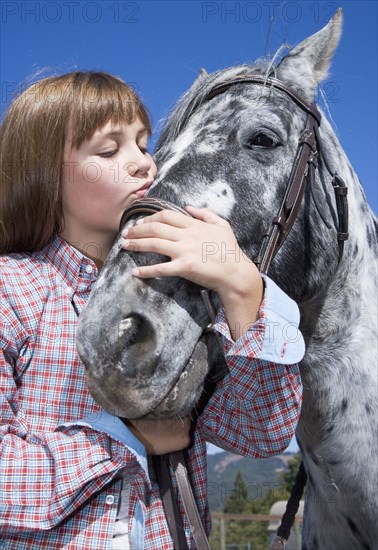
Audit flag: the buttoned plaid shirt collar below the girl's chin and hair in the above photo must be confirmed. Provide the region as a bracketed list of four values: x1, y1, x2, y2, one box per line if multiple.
[37, 235, 98, 290]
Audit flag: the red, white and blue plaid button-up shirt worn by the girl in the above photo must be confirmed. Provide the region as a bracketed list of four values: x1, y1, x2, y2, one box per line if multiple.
[0, 237, 303, 550]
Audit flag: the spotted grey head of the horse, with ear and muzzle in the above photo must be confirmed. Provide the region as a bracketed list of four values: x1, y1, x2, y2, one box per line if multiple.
[78, 13, 348, 418]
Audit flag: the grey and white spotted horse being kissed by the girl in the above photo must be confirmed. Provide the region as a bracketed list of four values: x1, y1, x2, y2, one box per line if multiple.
[77, 11, 378, 550]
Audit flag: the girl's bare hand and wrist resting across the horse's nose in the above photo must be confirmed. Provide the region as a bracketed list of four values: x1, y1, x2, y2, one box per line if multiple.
[122, 206, 263, 339]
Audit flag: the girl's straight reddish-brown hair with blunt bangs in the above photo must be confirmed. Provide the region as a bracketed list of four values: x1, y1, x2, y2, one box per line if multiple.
[0, 72, 151, 254]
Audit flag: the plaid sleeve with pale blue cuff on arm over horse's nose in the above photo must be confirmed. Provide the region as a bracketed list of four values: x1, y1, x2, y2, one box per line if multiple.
[199, 278, 305, 458]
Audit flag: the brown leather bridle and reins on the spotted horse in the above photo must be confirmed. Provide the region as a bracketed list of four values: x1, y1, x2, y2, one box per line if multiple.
[120, 74, 348, 550]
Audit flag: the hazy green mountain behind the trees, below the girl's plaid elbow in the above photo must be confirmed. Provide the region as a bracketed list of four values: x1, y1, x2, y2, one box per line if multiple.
[207, 451, 294, 512]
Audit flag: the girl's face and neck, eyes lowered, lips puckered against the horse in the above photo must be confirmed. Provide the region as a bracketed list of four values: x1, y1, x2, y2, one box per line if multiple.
[61, 119, 156, 255]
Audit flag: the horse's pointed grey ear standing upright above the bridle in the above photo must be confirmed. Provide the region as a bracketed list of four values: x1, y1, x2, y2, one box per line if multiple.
[277, 8, 343, 101]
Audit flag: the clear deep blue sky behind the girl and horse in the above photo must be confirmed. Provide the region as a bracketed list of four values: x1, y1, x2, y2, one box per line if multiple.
[0, 0, 377, 452]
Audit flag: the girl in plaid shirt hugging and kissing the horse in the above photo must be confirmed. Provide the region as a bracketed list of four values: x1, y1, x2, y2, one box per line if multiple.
[0, 72, 304, 550]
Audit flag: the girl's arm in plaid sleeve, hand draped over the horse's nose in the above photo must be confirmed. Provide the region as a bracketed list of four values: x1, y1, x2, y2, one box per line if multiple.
[123, 207, 304, 457]
